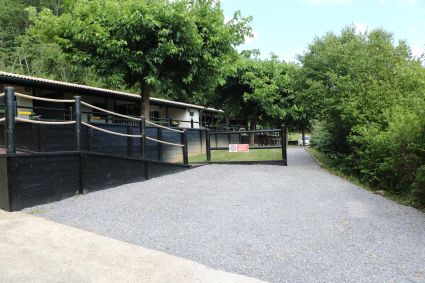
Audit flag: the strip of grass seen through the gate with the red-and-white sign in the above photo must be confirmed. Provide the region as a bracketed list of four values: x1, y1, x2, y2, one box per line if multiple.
[189, 148, 282, 163]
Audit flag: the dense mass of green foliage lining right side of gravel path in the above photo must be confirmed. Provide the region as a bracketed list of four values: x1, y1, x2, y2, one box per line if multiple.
[301, 28, 425, 206]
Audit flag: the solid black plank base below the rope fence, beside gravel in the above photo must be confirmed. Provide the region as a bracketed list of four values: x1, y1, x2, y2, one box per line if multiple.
[0, 152, 189, 211]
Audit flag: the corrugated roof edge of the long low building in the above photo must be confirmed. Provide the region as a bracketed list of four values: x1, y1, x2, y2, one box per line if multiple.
[0, 71, 223, 113]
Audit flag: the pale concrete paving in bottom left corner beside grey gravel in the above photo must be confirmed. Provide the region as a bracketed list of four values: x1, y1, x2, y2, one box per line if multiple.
[0, 210, 259, 283]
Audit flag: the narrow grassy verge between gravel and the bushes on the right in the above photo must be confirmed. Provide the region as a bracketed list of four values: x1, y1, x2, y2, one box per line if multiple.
[307, 147, 425, 212]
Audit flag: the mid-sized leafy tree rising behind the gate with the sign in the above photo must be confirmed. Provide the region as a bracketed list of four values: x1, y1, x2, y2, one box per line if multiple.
[213, 50, 291, 142]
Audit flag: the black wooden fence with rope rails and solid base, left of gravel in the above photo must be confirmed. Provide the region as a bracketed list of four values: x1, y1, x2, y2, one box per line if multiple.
[0, 88, 189, 211]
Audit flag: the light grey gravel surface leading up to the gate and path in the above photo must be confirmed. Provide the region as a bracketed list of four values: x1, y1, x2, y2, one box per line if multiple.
[27, 148, 425, 282]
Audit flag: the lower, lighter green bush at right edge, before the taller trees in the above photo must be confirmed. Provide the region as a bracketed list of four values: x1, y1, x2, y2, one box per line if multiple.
[350, 103, 425, 205]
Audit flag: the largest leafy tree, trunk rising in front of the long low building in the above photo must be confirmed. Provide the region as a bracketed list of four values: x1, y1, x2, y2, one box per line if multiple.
[26, 0, 250, 117]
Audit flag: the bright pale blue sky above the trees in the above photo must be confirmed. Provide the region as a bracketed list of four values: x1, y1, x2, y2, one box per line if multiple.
[221, 0, 425, 61]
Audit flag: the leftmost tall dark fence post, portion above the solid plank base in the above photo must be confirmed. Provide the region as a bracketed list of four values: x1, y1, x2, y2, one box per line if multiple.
[4, 87, 16, 153]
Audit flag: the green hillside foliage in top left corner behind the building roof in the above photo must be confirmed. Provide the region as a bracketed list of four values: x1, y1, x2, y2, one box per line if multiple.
[0, 0, 93, 85]
